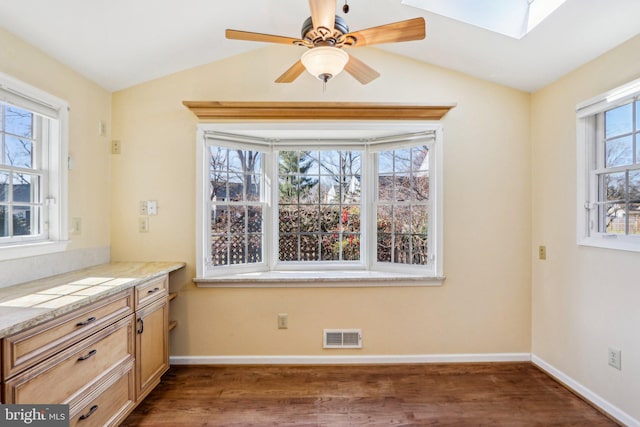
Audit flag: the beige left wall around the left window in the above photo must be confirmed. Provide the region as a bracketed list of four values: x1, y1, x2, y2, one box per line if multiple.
[0, 28, 111, 256]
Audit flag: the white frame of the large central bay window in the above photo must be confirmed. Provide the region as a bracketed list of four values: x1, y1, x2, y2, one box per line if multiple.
[195, 121, 444, 286]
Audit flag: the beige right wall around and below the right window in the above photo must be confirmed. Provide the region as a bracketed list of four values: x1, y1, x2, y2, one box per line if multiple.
[531, 33, 640, 420]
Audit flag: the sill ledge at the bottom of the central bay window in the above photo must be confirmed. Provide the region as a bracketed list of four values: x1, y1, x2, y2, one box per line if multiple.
[193, 270, 445, 288]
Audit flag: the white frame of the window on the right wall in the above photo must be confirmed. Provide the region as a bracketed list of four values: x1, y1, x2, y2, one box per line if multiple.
[576, 79, 640, 252]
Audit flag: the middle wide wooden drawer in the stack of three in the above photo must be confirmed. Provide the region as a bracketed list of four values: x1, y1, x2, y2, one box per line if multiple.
[4, 315, 135, 403]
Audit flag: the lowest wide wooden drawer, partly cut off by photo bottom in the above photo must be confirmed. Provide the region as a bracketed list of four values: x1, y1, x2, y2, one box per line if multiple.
[69, 361, 135, 427]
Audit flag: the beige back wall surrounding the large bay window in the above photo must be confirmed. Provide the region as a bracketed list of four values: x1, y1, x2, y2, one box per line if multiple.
[111, 46, 532, 356]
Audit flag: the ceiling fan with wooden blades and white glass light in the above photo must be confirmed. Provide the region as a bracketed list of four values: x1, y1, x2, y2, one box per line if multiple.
[226, 0, 425, 84]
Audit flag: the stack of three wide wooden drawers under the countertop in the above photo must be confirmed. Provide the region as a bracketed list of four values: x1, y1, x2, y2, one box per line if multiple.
[2, 289, 136, 427]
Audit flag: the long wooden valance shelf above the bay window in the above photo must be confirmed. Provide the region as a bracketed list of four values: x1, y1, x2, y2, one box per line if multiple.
[182, 101, 455, 120]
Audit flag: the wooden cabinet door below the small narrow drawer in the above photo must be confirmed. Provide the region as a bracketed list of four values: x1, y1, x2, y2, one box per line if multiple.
[136, 297, 169, 402]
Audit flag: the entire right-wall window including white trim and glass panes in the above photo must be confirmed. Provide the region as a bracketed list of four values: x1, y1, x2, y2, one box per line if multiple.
[576, 79, 640, 252]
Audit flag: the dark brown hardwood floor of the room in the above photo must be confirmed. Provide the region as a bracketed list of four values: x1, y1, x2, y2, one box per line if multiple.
[122, 363, 617, 427]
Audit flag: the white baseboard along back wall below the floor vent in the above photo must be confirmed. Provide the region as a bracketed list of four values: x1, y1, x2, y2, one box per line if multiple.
[171, 353, 531, 365]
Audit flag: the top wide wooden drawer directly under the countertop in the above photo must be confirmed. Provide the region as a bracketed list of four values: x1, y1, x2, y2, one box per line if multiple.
[2, 289, 133, 378]
